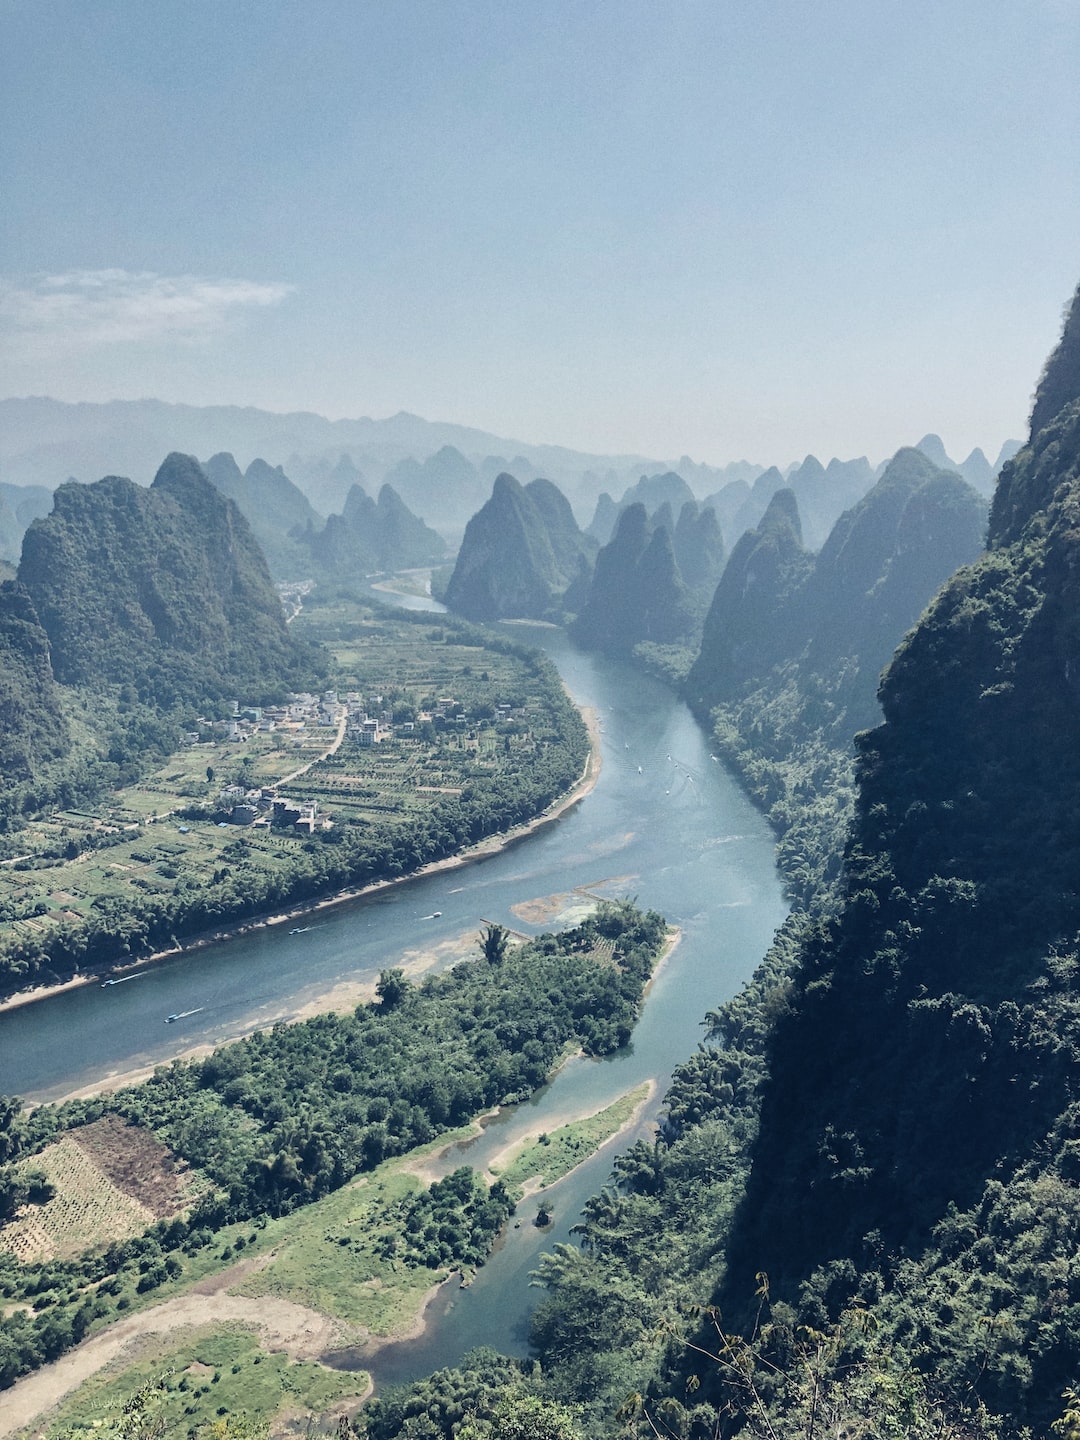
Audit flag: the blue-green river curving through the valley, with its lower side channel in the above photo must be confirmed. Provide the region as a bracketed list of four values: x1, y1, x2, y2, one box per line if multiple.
[0, 625, 786, 1385]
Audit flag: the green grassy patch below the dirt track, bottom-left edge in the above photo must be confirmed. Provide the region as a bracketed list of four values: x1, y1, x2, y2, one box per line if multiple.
[35, 1325, 367, 1440]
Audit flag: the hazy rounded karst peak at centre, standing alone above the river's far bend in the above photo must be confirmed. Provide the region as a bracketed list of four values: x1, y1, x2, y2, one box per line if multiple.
[446, 474, 593, 619]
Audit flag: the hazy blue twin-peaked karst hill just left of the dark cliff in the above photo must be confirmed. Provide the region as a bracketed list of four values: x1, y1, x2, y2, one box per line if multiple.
[687, 448, 986, 731]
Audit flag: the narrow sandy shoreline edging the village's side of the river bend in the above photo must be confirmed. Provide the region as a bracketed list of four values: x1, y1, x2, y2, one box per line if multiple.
[0, 706, 603, 1025]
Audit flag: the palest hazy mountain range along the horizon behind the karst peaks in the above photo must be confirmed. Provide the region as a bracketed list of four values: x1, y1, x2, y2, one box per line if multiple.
[0, 397, 1020, 553]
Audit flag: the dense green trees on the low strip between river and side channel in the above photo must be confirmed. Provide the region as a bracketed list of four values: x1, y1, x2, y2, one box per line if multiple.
[0, 901, 665, 1385]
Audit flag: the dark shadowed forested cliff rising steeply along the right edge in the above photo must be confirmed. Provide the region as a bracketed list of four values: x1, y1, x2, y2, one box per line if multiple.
[726, 292, 1080, 1426]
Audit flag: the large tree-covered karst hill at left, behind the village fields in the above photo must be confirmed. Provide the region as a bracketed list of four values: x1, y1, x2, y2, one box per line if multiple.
[19, 455, 311, 704]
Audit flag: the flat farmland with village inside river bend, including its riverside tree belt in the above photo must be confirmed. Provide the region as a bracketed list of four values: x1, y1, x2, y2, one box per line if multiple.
[0, 598, 585, 988]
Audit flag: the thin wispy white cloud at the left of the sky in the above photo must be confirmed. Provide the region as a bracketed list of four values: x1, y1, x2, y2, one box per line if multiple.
[0, 269, 292, 348]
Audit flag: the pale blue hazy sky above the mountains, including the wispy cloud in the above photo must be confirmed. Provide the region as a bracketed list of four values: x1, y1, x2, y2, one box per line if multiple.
[0, 0, 1080, 464]
